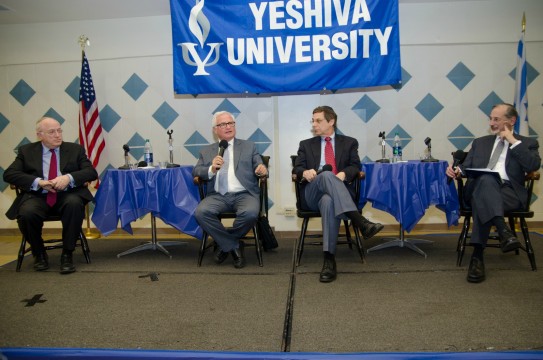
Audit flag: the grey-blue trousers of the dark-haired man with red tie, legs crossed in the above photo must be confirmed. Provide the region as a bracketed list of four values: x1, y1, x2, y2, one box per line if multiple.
[304, 171, 358, 254]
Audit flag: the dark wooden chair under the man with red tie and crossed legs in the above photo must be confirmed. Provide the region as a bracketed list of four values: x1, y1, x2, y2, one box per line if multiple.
[290, 155, 366, 266]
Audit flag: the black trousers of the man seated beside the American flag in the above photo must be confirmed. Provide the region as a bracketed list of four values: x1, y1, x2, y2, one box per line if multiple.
[17, 192, 86, 255]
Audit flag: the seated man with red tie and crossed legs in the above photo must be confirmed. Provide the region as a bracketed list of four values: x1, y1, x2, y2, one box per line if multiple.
[293, 106, 383, 282]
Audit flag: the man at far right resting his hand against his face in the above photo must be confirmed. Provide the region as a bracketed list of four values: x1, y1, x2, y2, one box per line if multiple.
[447, 104, 541, 283]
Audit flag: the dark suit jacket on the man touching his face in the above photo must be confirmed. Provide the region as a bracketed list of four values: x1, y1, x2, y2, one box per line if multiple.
[460, 134, 541, 207]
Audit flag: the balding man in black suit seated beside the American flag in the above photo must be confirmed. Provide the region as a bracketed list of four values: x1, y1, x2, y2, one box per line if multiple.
[4, 117, 98, 274]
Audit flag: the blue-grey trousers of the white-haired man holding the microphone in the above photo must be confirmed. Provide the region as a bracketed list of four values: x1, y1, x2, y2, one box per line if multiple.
[194, 191, 260, 252]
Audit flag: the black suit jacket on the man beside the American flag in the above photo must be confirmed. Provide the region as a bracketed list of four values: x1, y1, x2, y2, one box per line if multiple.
[4, 141, 98, 220]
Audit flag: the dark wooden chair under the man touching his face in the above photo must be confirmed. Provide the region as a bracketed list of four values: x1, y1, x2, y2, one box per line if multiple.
[453, 153, 540, 271]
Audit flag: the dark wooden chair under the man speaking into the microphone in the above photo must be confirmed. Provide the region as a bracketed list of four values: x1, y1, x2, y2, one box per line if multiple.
[194, 155, 270, 266]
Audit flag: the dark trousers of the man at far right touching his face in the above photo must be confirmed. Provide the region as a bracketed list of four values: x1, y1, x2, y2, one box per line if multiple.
[465, 175, 522, 246]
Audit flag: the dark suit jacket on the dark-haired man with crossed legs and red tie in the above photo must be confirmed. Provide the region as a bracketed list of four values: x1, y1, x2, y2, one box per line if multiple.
[293, 134, 360, 207]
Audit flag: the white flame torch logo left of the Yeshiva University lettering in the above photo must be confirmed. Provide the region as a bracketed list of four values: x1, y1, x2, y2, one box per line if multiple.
[178, 0, 223, 75]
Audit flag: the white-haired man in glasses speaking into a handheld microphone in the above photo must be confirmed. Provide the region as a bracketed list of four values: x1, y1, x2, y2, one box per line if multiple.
[192, 111, 268, 269]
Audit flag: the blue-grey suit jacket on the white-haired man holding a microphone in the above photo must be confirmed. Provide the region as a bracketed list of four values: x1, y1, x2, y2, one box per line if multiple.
[192, 138, 262, 196]
